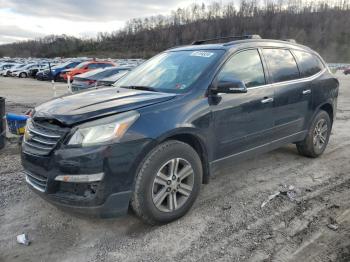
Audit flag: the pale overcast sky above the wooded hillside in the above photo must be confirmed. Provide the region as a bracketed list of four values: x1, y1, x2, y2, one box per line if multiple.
[0, 0, 216, 44]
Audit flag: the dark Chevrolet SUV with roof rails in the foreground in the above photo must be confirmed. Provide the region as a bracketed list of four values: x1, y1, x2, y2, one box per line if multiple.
[22, 36, 339, 224]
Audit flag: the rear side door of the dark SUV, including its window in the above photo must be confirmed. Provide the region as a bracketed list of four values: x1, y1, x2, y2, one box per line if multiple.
[262, 48, 312, 140]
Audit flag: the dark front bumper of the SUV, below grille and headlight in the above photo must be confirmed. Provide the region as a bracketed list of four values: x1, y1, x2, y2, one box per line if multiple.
[21, 139, 152, 217]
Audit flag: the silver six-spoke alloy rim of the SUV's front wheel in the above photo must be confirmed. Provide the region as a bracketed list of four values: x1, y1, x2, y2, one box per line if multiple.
[152, 158, 194, 212]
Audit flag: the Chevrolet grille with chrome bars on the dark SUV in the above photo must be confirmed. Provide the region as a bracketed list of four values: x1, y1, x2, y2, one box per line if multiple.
[23, 119, 68, 155]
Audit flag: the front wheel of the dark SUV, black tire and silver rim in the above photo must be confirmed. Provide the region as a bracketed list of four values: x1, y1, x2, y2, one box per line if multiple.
[131, 140, 203, 225]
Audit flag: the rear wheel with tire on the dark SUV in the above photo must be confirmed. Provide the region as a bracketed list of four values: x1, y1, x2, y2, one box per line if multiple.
[296, 110, 332, 158]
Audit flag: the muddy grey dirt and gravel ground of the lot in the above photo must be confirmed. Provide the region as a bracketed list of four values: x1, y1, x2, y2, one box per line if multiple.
[0, 74, 350, 262]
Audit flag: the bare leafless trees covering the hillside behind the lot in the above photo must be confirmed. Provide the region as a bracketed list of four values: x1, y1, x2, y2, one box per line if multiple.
[0, 0, 350, 62]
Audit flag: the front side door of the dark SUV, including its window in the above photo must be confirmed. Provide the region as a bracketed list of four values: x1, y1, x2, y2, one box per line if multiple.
[211, 49, 274, 161]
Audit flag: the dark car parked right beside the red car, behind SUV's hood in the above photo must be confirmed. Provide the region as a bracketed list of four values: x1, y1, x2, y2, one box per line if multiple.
[72, 66, 132, 92]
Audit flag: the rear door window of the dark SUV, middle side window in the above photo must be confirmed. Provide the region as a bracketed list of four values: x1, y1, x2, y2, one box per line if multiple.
[263, 49, 299, 83]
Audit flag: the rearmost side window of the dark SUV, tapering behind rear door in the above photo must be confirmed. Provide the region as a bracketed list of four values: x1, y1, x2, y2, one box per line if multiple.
[293, 51, 323, 77]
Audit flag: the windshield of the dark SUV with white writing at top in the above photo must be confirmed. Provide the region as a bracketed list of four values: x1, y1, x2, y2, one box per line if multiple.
[115, 50, 224, 93]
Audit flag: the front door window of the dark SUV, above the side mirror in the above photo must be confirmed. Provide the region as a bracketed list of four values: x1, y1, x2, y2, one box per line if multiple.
[218, 50, 265, 88]
